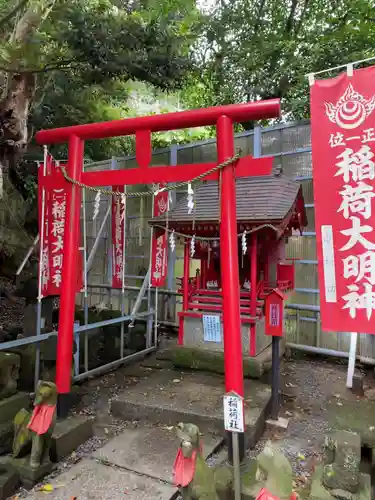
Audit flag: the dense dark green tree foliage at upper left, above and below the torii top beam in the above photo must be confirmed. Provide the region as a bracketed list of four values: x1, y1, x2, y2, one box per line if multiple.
[0, 0, 200, 160]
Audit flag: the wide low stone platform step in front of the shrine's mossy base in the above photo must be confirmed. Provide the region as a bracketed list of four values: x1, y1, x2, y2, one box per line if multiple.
[111, 370, 271, 446]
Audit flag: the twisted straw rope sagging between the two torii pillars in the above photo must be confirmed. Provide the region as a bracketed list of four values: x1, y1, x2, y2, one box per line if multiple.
[60, 153, 241, 198]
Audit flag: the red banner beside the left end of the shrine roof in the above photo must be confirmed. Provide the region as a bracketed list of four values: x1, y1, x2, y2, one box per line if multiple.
[151, 184, 169, 287]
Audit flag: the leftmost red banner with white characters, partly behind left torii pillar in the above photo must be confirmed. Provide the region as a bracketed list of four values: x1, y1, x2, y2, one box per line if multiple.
[38, 156, 83, 297]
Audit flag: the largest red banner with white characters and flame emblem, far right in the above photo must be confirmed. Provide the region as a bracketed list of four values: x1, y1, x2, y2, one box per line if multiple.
[311, 67, 375, 334]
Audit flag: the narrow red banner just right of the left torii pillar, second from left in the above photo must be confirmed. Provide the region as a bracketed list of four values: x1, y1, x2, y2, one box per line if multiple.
[112, 186, 126, 288]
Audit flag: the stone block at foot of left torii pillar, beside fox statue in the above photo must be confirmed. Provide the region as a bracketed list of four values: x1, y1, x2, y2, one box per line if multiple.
[51, 415, 93, 462]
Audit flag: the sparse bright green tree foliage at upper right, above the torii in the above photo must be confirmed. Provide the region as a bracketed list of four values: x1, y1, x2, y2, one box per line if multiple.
[184, 0, 375, 119]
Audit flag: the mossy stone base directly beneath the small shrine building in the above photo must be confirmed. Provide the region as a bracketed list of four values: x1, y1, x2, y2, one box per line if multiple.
[157, 342, 285, 379]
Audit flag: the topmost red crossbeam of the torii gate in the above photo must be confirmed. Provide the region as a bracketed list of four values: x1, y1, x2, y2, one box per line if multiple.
[35, 99, 280, 144]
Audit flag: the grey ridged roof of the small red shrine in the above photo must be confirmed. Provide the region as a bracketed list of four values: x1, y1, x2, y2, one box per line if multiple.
[150, 174, 306, 225]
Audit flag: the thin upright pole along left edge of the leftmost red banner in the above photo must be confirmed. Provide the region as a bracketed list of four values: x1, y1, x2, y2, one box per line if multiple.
[34, 146, 48, 391]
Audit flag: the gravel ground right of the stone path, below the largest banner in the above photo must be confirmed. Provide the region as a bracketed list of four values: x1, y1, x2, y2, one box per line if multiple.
[209, 358, 375, 488]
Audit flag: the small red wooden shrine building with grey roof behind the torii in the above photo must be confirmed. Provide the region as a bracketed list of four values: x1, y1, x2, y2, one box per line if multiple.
[150, 172, 307, 356]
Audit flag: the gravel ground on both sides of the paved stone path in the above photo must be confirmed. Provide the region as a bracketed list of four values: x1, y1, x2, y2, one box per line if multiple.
[8, 350, 375, 498]
